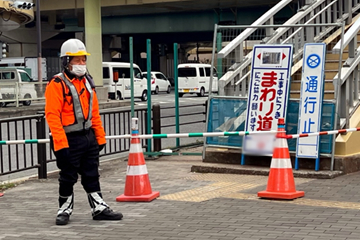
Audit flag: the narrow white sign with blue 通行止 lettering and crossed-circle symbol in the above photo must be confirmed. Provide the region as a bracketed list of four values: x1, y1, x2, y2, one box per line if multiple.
[296, 43, 326, 158]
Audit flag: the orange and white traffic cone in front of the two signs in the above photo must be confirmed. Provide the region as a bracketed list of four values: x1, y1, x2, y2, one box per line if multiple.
[258, 118, 305, 199]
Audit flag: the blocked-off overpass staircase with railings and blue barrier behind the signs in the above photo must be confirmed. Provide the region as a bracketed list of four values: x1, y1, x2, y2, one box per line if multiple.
[204, 0, 360, 172]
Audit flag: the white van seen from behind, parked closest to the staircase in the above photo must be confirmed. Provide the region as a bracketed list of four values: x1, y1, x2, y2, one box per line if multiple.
[178, 63, 218, 97]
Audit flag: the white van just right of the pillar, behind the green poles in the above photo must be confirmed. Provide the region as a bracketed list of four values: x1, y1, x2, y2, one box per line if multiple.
[102, 62, 147, 101]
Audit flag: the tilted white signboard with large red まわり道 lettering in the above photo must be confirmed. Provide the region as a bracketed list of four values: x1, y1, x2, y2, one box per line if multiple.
[243, 44, 293, 155]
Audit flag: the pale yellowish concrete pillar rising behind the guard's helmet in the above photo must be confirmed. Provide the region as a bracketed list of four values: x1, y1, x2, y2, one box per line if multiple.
[84, 0, 103, 86]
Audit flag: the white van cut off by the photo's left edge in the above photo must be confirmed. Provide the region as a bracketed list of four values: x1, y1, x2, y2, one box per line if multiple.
[0, 68, 37, 107]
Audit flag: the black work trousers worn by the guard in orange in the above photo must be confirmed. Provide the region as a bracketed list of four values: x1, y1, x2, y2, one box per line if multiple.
[51, 129, 100, 197]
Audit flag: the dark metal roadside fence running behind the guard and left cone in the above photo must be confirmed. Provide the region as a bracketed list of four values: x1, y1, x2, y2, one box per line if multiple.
[0, 104, 206, 178]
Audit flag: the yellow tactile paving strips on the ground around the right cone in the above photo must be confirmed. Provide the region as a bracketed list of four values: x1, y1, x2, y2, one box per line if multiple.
[159, 173, 360, 209]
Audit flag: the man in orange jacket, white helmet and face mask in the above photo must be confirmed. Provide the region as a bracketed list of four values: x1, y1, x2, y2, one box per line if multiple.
[45, 39, 123, 225]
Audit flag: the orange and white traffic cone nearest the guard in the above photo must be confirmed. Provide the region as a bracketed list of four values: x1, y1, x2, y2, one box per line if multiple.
[116, 118, 160, 202]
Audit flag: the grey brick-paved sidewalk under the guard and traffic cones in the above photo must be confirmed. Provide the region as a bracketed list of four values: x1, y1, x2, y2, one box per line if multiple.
[0, 147, 360, 240]
